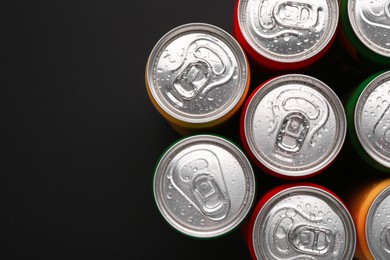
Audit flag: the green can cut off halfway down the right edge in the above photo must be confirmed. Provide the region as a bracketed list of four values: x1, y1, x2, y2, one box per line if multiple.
[345, 71, 390, 172]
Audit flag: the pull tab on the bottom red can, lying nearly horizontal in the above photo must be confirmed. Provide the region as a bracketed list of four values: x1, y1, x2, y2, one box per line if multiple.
[289, 224, 335, 256]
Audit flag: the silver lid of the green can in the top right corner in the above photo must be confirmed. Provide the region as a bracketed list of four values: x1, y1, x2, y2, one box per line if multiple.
[348, 0, 390, 57]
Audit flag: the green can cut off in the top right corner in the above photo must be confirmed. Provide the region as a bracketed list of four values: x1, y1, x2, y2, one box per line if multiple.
[339, 0, 390, 68]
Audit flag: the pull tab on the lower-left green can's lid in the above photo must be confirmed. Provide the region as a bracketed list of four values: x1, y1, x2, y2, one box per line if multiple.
[191, 172, 230, 220]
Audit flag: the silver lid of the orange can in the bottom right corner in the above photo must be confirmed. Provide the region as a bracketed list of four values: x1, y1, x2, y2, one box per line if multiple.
[366, 187, 390, 260]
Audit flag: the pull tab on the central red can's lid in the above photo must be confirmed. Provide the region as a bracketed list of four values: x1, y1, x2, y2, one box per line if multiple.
[275, 112, 310, 153]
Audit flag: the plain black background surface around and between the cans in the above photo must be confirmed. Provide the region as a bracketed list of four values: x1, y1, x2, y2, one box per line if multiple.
[0, 0, 381, 259]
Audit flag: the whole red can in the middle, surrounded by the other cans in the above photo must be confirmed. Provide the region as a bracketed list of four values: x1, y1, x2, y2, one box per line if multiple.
[240, 74, 347, 179]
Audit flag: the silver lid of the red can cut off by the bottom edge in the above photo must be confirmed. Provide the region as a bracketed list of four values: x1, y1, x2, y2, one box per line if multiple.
[252, 186, 356, 260]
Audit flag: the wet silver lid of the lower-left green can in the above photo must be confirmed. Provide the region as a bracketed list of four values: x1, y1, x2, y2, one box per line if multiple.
[154, 135, 255, 238]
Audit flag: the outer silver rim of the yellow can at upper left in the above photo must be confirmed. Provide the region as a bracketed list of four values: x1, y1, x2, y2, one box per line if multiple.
[145, 22, 250, 125]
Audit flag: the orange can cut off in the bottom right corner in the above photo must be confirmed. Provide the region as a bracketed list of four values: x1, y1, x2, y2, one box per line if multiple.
[345, 178, 390, 260]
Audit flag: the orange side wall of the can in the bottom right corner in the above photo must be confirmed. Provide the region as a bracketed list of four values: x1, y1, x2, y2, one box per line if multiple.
[345, 179, 390, 260]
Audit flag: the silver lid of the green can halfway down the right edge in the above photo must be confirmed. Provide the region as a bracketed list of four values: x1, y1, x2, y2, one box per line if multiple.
[354, 71, 390, 168]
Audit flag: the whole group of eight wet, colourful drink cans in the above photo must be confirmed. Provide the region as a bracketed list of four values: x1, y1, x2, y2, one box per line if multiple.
[145, 0, 390, 260]
